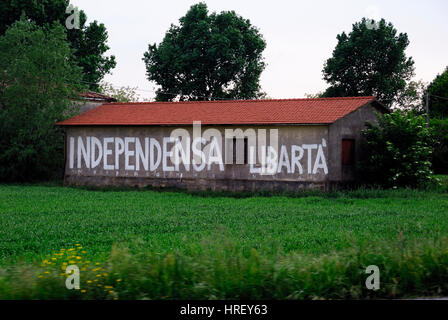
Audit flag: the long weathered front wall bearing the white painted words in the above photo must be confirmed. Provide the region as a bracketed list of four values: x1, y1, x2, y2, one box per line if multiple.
[65, 125, 329, 191]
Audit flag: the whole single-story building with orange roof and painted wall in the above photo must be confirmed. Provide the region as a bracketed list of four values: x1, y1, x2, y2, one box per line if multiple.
[57, 97, 386, 191]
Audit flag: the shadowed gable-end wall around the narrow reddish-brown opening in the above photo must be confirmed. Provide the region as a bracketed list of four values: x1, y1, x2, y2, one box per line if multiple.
[328, 104, 378, 182]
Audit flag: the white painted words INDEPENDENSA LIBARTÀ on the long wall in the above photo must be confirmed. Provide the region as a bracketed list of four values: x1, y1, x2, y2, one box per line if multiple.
[68, 122, 328, 175]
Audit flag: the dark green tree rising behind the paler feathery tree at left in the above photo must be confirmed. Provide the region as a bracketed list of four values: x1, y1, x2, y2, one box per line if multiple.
[0, 0, 116, 90]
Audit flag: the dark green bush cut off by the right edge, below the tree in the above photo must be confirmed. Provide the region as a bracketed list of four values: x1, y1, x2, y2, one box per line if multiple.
[429, 119, 448, 174]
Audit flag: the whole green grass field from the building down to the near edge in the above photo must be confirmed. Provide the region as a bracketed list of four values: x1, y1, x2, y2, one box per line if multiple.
[0, 185, 448, 299]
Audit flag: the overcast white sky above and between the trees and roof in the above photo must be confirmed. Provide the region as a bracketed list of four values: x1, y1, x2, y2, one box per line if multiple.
[71, 0, 448, 99]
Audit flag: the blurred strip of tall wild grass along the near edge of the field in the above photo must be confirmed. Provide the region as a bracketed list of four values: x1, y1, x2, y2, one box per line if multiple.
[0, 238, 448, 299]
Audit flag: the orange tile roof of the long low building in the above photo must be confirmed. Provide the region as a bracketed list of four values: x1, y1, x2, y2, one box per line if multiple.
[57, 97, 376, 126]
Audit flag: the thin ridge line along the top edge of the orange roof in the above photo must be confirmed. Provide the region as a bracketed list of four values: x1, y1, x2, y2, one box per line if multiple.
[105, 96, 375, 105]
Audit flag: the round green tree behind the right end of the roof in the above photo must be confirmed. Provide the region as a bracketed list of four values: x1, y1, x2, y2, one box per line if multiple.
[323, 18, 414, 106]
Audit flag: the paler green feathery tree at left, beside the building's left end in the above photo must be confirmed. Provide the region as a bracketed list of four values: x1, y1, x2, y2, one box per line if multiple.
[0, 20, 83, 181]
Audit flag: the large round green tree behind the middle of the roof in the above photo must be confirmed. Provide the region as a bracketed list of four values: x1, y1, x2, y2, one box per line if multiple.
[143, 3, 266, 101]
